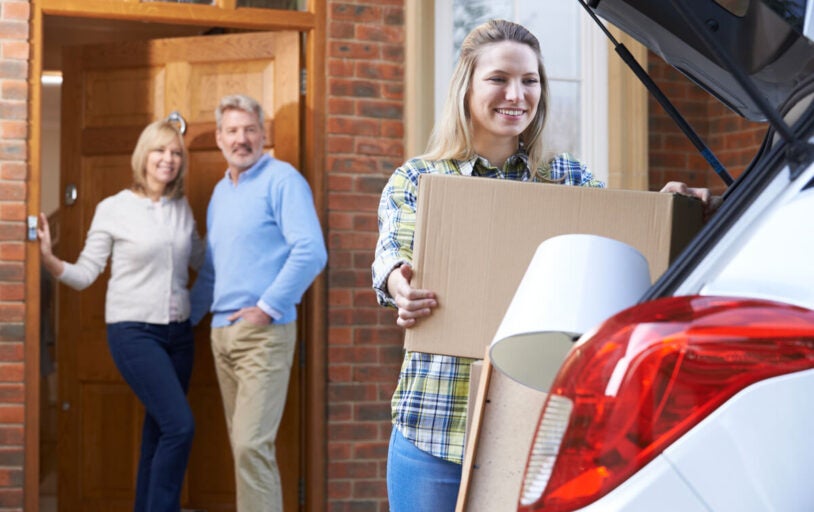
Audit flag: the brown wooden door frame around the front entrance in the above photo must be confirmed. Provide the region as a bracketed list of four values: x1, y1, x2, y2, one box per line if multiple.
[23, 0, 327, 512]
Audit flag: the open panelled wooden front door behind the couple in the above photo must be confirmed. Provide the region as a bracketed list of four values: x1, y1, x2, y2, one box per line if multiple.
[57, 32, 303, 512]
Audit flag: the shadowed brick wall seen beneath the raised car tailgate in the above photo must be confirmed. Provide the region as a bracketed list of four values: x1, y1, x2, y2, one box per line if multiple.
[648, 53, 766, 193]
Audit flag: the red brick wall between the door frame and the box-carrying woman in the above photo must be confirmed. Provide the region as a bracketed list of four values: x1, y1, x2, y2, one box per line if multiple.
[326, 0, 405, 512]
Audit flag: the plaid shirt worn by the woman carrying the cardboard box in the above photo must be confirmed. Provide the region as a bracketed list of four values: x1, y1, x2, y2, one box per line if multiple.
[372, 150, 604, 464]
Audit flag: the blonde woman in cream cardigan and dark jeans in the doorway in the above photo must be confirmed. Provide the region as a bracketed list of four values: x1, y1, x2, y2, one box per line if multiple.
[38, 121, 204, 512]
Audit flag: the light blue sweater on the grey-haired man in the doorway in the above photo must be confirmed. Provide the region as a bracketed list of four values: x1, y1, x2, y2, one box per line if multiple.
[191, 155, 328, 327]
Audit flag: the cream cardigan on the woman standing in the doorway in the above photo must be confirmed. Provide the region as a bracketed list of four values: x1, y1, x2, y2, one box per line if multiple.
[59, 190, 204, 324]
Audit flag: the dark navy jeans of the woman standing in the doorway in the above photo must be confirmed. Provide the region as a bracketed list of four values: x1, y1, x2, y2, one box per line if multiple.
[107, 321, 195, 512]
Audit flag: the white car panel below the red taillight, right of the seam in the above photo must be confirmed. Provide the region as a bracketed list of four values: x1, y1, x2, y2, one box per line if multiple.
[664, 370, 814, 512]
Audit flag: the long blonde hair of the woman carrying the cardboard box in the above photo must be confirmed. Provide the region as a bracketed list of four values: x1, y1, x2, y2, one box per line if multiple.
[421, 19, 548, 174]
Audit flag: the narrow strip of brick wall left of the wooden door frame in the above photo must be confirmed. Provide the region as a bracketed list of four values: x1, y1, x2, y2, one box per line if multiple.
[0, 0, 30, 510]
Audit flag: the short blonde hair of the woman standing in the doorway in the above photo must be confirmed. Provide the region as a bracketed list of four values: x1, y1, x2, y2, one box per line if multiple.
[130, 120, 189, 199]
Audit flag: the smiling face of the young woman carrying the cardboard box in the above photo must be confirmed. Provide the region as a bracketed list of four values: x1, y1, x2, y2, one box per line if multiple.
[468, 41, 541, 147]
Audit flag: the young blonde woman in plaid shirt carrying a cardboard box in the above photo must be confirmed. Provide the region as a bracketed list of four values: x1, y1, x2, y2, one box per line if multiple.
[372, 20, 709, 512]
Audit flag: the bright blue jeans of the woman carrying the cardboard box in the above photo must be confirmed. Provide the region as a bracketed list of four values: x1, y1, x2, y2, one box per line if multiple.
[387, 427, 462, 512]
